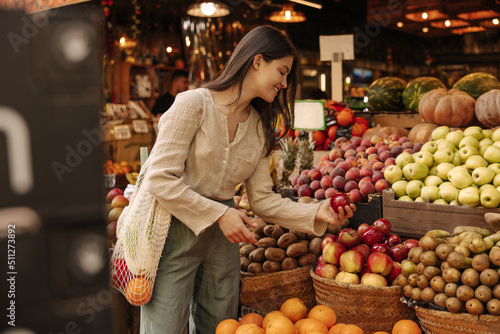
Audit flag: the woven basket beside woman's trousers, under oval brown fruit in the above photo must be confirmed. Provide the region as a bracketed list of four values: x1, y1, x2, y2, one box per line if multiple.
[240, 266, 316, 314]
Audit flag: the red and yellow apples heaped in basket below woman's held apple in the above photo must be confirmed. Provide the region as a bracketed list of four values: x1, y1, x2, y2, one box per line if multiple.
[315, 218, 418, 287]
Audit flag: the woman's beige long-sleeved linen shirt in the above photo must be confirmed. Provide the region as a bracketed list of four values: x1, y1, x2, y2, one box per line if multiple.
[146, 88, 326, 235]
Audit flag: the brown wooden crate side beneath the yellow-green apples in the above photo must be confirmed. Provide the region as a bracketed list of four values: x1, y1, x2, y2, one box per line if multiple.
[382, 189, 500, 239]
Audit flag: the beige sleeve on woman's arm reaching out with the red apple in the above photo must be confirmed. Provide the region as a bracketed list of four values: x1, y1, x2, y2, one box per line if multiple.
[246, 151, 327, 235]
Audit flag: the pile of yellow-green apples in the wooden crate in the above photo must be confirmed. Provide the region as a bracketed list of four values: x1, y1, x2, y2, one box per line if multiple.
[384, 126, 500, 208]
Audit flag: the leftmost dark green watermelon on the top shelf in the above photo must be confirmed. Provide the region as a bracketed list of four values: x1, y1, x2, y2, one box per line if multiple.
[367, 77, 406, 111]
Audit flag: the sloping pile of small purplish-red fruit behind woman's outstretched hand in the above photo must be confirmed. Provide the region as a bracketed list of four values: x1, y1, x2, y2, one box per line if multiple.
[292, 134, 419, 203]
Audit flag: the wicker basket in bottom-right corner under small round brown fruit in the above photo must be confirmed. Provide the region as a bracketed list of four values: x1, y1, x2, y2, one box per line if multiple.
[415, 306, 500, 334]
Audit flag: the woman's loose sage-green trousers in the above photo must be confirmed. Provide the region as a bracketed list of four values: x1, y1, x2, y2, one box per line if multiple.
[141, 200, 240, 334]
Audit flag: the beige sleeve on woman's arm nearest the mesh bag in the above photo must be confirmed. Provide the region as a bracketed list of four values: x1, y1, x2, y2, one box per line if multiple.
[146, 92, 228, 235]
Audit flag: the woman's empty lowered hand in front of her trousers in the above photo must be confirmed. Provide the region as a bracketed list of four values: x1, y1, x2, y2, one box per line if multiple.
[217, 208, 257, 245]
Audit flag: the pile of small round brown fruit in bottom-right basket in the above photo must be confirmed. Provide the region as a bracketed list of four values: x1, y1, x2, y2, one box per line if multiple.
[395, 226, 500, 315]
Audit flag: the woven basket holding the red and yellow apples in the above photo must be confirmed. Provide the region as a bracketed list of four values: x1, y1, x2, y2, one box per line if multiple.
[310, 270, 415, 334]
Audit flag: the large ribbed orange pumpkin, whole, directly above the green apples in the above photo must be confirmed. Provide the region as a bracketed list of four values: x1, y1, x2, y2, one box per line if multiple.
[418, 88, 476, 126]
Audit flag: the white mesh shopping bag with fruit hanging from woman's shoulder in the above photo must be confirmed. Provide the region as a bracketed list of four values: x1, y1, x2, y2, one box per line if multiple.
[110, 161, 172, 306]
